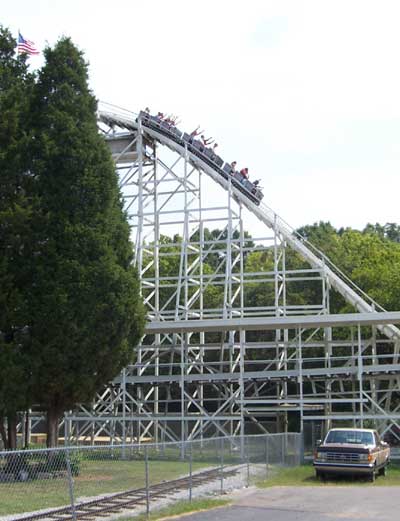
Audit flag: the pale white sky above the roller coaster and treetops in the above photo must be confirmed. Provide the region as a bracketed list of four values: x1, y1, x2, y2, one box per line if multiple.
[5, 0, 400, 228]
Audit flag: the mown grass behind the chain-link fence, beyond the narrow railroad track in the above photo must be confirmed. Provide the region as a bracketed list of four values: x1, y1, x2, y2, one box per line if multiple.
[0, 460, 209, 515]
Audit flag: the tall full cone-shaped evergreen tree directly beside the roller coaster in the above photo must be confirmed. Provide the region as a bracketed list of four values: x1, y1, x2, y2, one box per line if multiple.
[30, 38, 145, 446]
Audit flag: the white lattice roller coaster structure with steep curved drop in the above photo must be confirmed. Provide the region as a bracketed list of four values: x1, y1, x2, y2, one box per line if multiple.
[64, 106, 400, 441]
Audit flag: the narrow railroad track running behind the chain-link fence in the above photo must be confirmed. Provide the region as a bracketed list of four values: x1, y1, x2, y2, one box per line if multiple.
[15, 467, 239, 521]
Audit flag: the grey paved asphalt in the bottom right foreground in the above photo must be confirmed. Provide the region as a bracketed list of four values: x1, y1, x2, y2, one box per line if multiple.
[182, 486, 400, 521]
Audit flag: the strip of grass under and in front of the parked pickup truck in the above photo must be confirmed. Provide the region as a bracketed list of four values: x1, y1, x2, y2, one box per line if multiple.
[257, 463, 400, 488]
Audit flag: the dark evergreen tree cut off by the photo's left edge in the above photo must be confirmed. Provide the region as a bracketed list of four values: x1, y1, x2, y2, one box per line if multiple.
[0, 27, 34, 448]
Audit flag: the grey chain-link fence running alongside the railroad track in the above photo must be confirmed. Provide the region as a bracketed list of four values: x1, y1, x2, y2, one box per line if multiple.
[0, 433, 302, 521]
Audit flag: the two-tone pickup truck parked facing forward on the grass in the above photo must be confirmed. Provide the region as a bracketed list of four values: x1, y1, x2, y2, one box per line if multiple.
[313, 429, 390, 481]
